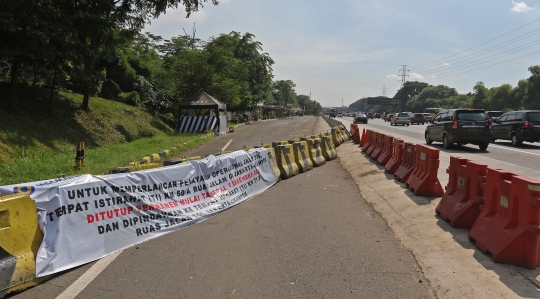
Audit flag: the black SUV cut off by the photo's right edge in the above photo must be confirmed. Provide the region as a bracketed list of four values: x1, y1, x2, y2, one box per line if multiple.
[492, 110, 540, 145]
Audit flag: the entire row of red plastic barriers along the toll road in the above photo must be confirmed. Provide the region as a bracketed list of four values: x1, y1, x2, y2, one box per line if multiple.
[357, 129, 540, 269]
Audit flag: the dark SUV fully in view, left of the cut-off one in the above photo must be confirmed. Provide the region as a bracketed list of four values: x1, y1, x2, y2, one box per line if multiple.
[424, 108, 492, 150]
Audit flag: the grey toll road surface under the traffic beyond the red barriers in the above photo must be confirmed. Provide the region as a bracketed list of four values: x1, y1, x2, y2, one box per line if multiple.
[342, 118, 540, 181]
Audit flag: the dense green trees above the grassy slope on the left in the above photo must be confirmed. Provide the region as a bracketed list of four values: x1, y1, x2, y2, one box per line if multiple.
[0, 0, 321, 114]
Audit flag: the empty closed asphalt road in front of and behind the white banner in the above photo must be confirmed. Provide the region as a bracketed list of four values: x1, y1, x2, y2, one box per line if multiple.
[7, 116, 435, 298]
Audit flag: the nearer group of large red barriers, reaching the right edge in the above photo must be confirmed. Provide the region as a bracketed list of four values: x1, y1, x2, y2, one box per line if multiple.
[436, 156, 540, 269]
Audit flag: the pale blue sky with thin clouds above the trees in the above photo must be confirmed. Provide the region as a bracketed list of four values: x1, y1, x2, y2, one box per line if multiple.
[143, 0, 540, 106]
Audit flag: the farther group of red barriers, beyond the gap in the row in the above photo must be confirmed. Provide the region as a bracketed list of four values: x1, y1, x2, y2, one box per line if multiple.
[356, 129, 444, 196]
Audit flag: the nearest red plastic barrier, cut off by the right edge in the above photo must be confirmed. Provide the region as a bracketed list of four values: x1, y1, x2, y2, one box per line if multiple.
[469, 167, 540, 269]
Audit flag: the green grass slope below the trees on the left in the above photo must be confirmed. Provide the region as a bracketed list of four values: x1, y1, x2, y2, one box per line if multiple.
[0, 83, 212, 185]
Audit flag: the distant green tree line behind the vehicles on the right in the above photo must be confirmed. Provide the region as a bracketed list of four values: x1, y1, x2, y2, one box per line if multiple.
[349, 65, 540, 112]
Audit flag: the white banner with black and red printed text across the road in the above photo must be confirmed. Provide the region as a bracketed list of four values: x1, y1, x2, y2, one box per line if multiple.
[34, 148, 276, 277]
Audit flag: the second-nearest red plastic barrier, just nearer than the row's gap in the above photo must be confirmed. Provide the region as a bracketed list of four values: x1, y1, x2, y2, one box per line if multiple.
[435, 156, 487, 229]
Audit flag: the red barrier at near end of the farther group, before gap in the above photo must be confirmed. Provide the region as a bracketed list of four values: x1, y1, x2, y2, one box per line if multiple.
[405, 144, 444, 196]
